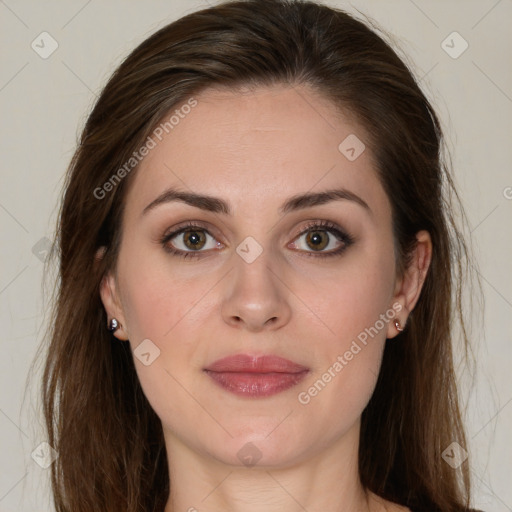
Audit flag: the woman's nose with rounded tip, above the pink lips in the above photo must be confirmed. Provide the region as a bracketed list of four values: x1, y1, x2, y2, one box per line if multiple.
[222, 251, 291, 332]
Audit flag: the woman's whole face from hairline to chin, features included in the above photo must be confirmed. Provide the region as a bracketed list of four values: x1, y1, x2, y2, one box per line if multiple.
[102, 86, 414, 466]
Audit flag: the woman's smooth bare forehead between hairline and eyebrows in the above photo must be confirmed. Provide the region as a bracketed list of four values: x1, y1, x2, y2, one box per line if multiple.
[127, 85, 383, 215]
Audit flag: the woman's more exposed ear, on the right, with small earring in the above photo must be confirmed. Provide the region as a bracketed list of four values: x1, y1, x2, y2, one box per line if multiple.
[387, 230, 432, 338]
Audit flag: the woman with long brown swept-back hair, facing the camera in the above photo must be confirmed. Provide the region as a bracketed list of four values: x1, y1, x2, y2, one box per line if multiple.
[39, 0, 480, 512]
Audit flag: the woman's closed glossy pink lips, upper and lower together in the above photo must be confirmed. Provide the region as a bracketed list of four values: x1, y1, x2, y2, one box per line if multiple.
[204, 354, 309, 398]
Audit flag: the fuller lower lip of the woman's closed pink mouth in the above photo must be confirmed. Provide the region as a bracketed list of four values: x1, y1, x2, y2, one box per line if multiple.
[205, 370, 308, 398]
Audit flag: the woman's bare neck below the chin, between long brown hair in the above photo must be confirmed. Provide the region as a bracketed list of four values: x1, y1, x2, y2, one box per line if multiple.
[165, 424, 383, 512]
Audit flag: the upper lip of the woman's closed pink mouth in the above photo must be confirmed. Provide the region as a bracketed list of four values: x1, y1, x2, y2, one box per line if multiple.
[205, 354, 309, 373]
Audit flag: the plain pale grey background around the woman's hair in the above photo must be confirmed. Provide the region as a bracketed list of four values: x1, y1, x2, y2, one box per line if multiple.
[0, 0, 512, 512]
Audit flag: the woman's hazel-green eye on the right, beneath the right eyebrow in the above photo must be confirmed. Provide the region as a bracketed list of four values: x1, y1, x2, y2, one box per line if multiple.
[291, 221, 354, 257]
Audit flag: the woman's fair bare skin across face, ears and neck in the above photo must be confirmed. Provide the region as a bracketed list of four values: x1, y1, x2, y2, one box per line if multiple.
[101, 85, 432, 512]
